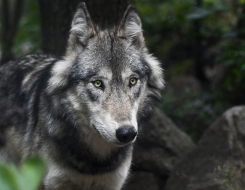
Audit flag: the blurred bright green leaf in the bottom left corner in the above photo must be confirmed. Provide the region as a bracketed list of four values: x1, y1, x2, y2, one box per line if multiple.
[0, 158, 45, 190]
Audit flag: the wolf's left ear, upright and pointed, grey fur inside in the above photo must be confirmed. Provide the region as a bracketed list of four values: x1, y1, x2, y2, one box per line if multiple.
[68, 3, 95, 50]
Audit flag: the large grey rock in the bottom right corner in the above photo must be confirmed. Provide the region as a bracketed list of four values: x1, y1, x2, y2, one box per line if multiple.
[166, 106, 245, 190]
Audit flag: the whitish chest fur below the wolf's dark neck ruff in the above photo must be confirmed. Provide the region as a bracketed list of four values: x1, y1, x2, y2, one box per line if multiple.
[43, 151, 132, 190]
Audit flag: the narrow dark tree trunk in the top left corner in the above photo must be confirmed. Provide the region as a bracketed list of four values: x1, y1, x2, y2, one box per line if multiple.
[0, 0, 23, 65]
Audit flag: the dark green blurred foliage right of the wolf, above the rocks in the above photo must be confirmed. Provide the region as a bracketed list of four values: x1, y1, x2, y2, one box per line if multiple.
[133, 0, 245, 141]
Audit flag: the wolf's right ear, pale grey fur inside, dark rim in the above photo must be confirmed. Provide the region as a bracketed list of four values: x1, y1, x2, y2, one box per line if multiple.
[118, 5, 144, 44]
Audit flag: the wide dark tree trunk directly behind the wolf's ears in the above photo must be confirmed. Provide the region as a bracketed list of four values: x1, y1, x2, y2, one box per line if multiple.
[38, 0, 129, 55]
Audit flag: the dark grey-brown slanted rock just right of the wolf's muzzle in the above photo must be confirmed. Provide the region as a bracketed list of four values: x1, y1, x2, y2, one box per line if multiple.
[133, 109, 195, 176]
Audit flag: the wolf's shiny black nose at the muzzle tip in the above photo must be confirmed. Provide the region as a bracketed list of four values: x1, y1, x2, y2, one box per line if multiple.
[116, 126, 137, 143]
